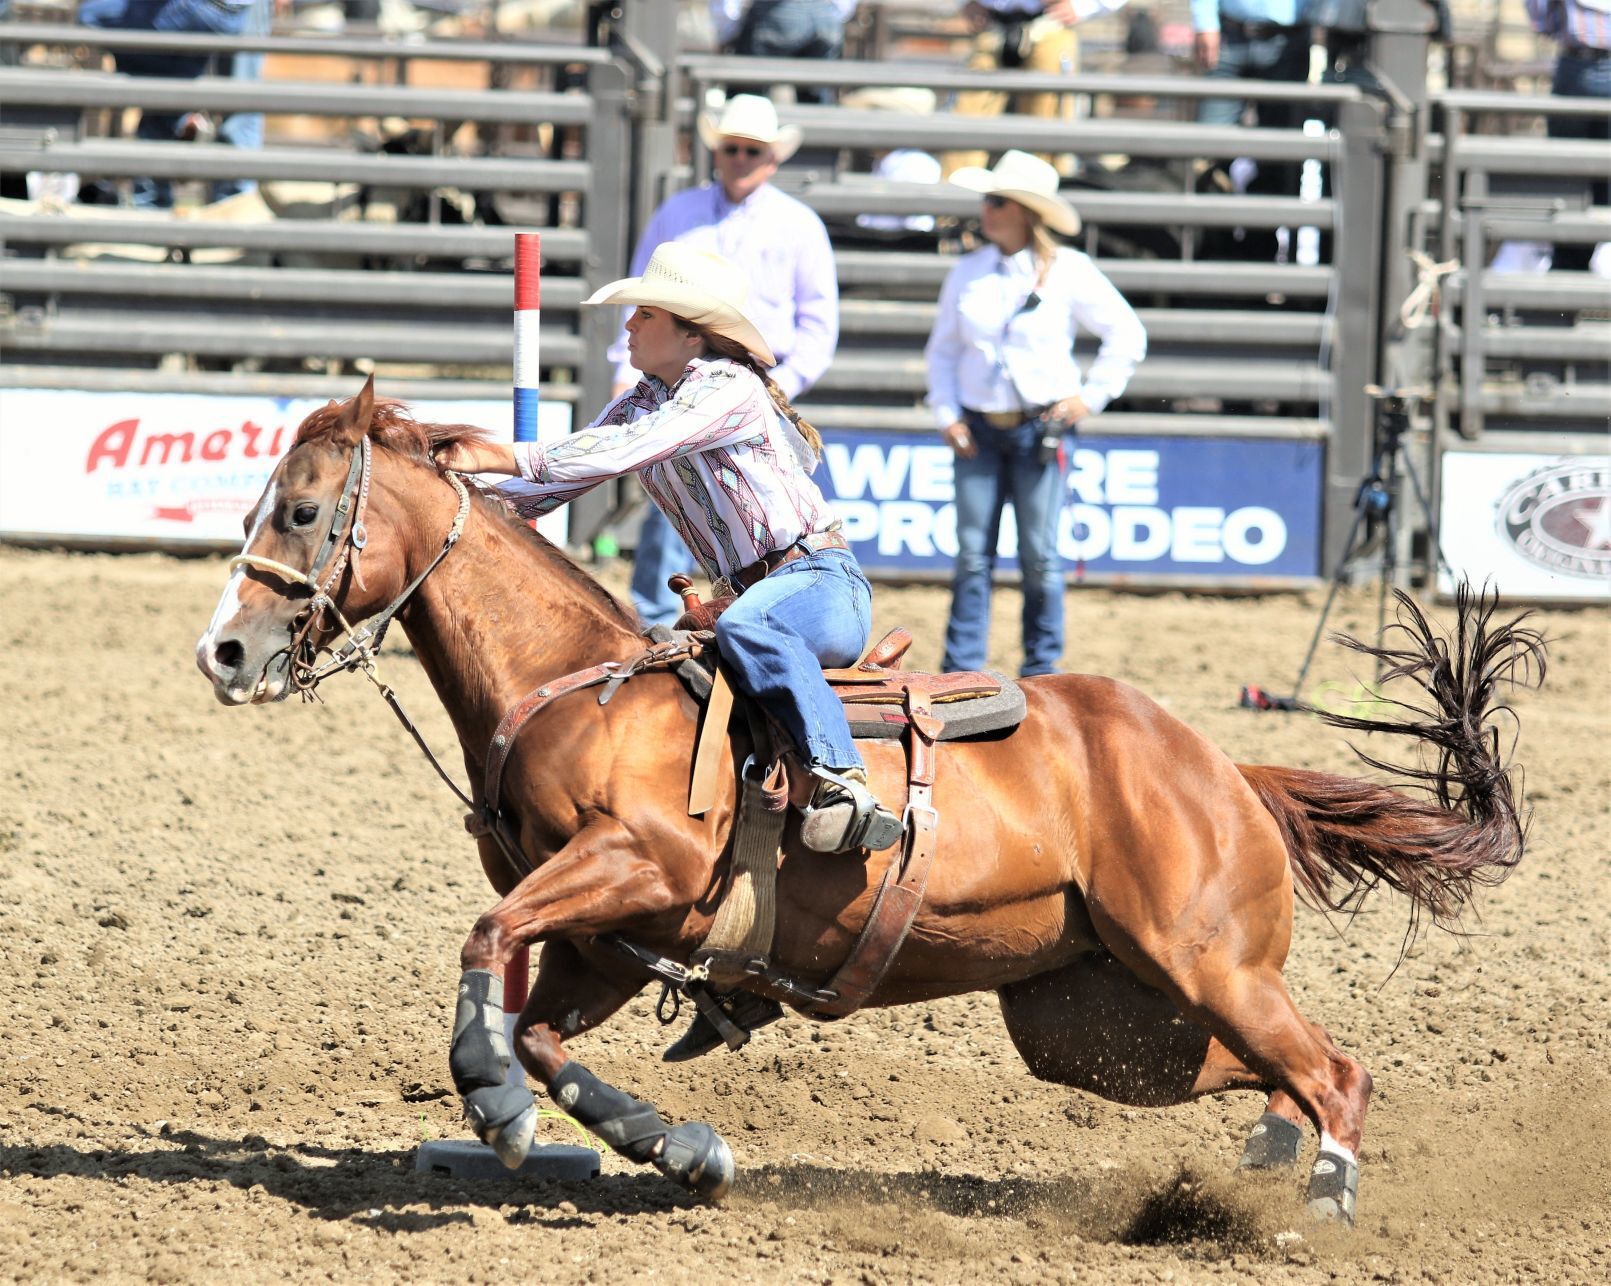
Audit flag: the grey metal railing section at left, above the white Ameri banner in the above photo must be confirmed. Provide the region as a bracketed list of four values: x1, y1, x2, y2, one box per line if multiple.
[0, 23, 633, 535]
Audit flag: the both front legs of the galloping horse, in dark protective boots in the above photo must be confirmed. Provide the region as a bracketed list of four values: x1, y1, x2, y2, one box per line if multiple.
[448, 820, 733, 1201]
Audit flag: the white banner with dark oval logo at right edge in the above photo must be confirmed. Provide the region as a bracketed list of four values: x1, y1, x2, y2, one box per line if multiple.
[1439, 451, 1611, 601]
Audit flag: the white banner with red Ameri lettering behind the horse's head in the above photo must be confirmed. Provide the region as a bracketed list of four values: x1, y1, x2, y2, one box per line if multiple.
[0, 388, 570, 546]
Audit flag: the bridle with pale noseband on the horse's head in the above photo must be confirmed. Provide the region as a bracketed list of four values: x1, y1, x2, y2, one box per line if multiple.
[229, 434, 470, 699]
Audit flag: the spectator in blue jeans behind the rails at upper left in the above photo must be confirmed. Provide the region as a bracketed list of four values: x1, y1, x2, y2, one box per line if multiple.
[79, 0, 253, 208]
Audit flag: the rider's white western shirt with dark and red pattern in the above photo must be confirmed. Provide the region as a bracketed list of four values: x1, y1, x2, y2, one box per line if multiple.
[499, 358, 833, 580]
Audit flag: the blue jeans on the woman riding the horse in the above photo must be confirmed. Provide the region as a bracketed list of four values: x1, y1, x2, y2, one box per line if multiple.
[715, 550, 873, 769]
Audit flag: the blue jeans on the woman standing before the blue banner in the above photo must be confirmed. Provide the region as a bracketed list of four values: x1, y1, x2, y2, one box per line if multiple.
[941, 416, 1065, 675]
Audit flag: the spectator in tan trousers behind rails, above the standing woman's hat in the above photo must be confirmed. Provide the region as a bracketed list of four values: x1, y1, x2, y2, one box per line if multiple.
[944, 0, 1126, 174]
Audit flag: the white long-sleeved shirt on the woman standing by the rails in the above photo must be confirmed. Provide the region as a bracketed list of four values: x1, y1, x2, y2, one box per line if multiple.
[923, 245, 1147, 429]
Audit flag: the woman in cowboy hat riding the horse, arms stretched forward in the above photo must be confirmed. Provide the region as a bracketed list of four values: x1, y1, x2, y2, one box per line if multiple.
[443, 242, 901, 852]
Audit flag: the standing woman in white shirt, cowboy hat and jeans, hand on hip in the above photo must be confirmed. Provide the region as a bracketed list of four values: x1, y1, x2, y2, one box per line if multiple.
[925, 151, 1147, 675]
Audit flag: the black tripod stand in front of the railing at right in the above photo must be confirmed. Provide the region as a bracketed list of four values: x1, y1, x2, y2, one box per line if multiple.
[1284, 384, 1448, 709]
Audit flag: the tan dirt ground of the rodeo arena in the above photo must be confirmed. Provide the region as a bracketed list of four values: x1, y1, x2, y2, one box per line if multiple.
[0, 548, 1611, 1283]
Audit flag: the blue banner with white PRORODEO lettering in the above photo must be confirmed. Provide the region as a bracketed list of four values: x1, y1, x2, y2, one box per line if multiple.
[815, 429, 1324, 580]
